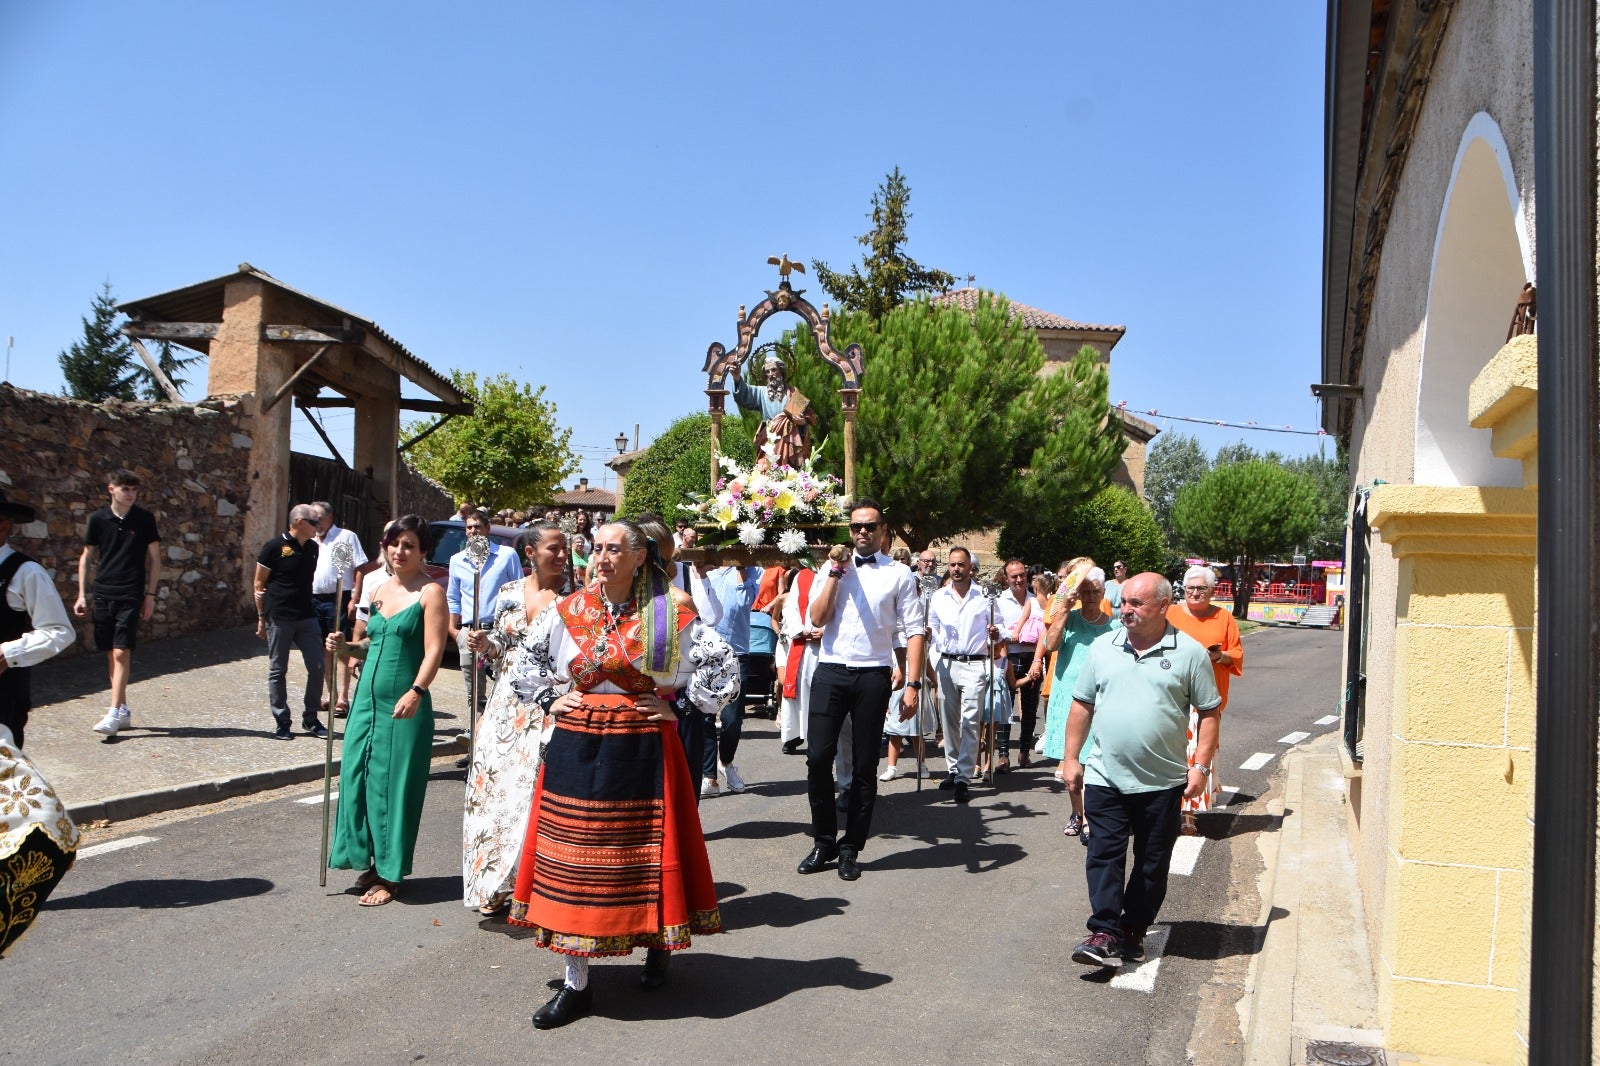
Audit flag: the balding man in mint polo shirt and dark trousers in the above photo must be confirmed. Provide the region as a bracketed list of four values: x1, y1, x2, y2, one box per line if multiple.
[1061, 573, 1222, 967]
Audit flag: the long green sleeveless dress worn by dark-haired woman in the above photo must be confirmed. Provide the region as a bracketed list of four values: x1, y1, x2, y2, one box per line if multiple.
[328, 600, 434, 882]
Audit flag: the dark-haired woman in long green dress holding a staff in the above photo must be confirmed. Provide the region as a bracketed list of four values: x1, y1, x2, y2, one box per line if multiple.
[328, 514, 450, 908]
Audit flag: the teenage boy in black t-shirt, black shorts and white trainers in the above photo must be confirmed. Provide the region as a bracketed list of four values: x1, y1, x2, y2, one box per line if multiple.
[72, 471, 162, 736]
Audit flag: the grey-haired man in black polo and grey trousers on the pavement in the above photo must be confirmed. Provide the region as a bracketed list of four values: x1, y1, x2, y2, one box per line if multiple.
[256, 504, 328, 739]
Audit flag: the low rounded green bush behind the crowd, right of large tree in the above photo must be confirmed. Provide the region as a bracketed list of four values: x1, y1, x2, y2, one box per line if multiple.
[998, 485, 1166, 573]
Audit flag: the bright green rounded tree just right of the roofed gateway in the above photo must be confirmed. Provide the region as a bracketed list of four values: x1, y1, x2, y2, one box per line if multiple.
[406, 370, 578, 512]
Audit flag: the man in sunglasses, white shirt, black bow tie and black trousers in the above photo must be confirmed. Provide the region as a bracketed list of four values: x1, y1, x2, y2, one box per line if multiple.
[798, 499, 926, 880]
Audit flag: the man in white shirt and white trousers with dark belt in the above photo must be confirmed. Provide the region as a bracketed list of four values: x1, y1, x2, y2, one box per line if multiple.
[928, 547, 1000, 804]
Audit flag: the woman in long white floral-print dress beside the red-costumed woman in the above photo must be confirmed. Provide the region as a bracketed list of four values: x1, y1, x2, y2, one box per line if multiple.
[461, 522, 571, 917]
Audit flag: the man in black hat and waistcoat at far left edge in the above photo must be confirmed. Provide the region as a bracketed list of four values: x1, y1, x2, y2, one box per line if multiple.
[0, 493, 77, 747]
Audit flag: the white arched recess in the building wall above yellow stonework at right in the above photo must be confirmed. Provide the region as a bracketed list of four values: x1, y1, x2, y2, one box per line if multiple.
[1413, 112, 1533, 485]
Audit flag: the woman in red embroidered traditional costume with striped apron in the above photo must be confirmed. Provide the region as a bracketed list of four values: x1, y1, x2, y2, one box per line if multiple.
[510, 522, 739, 1029]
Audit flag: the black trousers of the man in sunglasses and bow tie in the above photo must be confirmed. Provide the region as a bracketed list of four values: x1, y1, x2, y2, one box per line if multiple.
[805, 663, 893, 852]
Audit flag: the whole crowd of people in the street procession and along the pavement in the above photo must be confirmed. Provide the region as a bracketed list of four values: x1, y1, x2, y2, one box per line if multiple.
[0, 471, 1243, 1028]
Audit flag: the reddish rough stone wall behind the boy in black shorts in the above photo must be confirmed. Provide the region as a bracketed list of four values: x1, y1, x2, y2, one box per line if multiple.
[0, 384, 253, 653]
